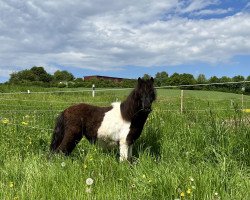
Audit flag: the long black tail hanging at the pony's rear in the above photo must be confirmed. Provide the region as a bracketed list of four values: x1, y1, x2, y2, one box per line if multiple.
[50, 112, 65, 152]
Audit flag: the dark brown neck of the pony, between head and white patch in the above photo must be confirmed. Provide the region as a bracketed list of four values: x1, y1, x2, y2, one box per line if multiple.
[121, 89, 141, 121]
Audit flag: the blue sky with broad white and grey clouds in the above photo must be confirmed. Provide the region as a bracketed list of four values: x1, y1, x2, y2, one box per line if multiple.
[0, 0, 250, 82]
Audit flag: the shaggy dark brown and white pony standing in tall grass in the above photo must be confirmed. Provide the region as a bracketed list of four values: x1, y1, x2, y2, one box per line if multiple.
[50, 77, 156, 161]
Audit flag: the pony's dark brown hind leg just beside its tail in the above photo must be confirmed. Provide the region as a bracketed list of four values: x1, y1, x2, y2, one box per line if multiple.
[57, 130, 83, 155]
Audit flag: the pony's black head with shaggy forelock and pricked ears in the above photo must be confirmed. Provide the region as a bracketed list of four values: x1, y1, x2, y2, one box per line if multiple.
[136, 77, 156, 112]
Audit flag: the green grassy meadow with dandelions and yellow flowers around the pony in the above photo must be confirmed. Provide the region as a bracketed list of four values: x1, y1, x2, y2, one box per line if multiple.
[0, 86, 250, 200]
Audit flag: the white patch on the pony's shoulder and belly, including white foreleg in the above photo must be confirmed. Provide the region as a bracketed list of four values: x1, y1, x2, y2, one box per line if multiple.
[97, 102, 131, 160]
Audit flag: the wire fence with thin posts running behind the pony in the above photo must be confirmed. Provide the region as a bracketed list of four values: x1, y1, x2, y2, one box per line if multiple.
[0, 81, 250, 132]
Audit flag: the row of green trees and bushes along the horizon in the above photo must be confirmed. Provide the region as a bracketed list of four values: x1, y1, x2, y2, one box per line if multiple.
[3, 66, 250, 93]
